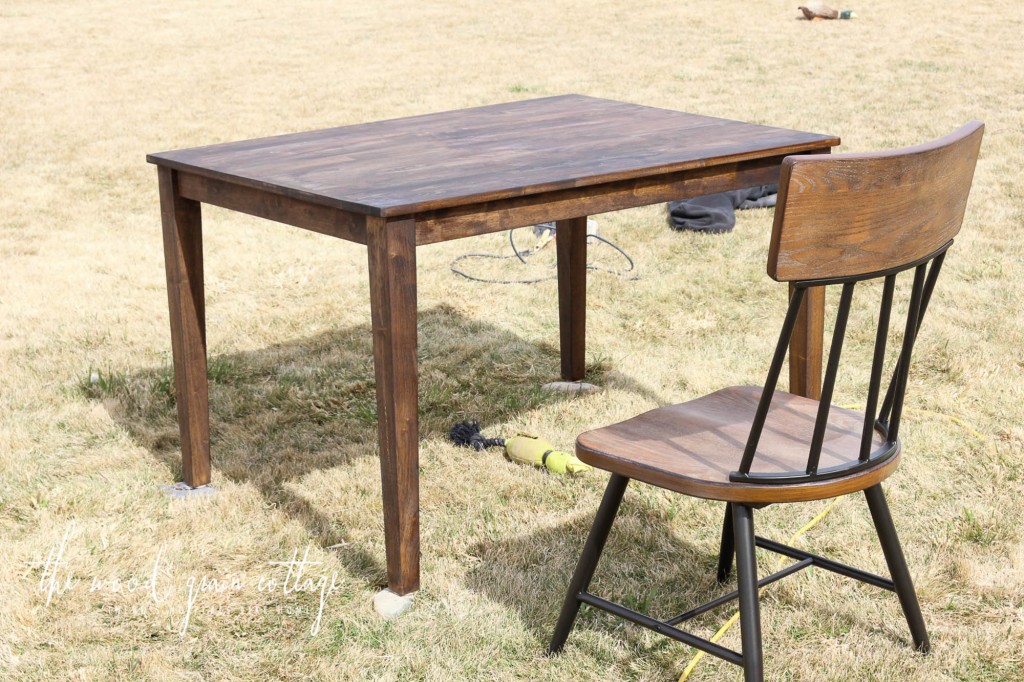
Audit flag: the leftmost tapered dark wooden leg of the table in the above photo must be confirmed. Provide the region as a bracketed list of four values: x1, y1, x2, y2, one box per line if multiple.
[158, 167, 210, 487]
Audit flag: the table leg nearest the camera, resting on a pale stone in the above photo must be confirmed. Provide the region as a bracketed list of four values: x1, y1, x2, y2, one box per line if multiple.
[367, 218, 420, 595]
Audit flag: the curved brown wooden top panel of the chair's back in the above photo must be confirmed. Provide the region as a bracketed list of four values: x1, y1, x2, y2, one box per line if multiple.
[768, 121, 985, 282]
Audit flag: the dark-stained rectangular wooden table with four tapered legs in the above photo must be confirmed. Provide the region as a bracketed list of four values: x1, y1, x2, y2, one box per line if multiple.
[146, 95, 839, 595]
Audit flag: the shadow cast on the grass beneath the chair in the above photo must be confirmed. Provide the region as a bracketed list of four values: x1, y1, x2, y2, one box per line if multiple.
[466, 491, 912, 655]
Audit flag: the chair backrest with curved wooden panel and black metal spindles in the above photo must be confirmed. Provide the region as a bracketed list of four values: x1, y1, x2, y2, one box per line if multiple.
[732, 121, 984, 483]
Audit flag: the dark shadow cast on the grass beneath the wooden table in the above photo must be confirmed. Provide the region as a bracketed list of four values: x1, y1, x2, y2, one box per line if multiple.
[83, 306, 663, 583]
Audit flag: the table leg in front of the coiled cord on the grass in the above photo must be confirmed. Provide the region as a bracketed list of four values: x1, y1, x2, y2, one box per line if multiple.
[555, 216, 587, 381]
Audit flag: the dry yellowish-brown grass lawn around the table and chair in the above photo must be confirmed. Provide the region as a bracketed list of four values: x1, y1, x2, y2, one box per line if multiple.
[0, 0, 1024, 680]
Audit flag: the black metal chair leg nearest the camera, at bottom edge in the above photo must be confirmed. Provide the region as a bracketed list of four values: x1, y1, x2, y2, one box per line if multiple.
[731, 504, 765, 682]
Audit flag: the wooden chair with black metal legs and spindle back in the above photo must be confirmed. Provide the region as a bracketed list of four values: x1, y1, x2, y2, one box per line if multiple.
[549, 121, 984, 681]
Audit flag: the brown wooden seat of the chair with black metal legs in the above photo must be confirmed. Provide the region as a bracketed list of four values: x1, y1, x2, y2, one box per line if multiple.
[577, 386, 899, 504]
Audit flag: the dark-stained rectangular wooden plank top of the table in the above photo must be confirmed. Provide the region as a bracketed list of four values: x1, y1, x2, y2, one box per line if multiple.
[146, 95, 840, 217]
